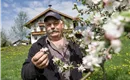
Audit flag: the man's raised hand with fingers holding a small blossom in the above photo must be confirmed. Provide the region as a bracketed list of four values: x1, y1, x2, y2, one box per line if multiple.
[31, 49, 49, 69]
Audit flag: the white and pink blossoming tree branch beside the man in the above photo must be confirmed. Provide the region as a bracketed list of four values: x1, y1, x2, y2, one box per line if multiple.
[44, 0, 130, 80]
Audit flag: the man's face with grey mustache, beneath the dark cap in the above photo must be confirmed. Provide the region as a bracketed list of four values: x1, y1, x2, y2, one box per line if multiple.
[45, 17, 63, 38]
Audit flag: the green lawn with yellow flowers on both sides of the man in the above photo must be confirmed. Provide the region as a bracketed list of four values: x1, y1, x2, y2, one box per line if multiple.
[0, 37, 130, 80]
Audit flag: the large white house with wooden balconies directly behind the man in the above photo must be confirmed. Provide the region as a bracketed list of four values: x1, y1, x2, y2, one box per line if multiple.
[25, 7, 75, 44]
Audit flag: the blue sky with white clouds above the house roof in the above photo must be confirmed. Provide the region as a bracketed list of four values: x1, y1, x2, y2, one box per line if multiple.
[0, 0, 82, 33]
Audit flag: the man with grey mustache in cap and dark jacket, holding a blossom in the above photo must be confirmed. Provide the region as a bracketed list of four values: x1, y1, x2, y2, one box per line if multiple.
[21, 11, 82, 80]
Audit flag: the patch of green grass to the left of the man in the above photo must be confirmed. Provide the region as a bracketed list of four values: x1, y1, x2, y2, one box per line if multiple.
[0, 46, 30, 80]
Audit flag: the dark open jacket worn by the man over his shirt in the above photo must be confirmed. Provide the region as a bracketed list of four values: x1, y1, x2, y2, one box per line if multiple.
[21, 36, 82, 80]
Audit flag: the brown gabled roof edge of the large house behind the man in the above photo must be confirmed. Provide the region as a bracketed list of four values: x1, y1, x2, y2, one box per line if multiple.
[25, 8, 74, 28]
